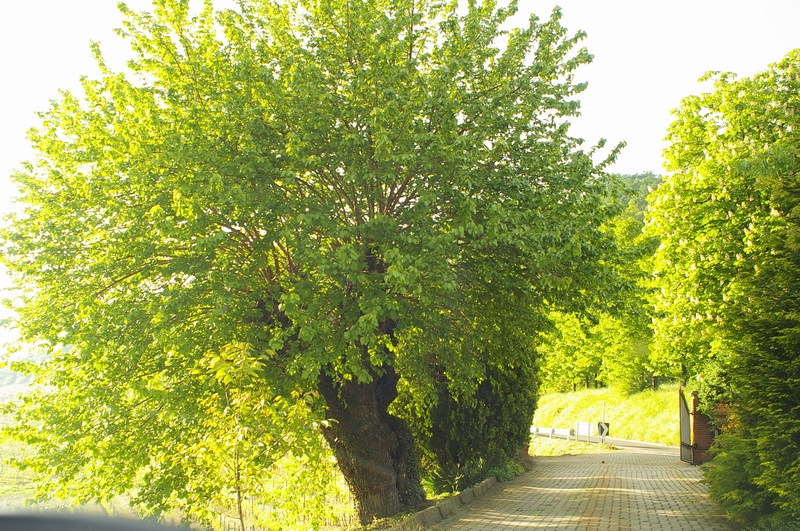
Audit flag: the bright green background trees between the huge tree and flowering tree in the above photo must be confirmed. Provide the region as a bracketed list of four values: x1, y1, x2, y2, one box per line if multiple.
[540, 173, 661, 393]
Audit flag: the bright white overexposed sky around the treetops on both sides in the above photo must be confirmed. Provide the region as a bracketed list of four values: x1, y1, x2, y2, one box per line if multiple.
[0, 0, 800, 210]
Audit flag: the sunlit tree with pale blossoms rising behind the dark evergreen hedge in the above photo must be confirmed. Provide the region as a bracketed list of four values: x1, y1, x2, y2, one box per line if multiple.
[649, 51, 791, 382]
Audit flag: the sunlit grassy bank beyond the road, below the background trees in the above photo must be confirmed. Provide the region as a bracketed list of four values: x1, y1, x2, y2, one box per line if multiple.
[533, 384, 680, 446]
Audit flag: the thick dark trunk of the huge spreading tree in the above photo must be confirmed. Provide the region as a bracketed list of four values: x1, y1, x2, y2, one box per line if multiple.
[319, 368, 425, 525]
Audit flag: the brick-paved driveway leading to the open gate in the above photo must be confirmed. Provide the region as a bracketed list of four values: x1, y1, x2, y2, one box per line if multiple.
[431, 448, 733, 531]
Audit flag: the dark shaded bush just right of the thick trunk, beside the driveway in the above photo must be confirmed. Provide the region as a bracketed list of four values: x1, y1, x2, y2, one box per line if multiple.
[395, 351, 539, 494]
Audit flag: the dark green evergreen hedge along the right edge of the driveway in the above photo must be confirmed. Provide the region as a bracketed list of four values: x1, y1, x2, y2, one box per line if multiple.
[709, 132, 800, 525]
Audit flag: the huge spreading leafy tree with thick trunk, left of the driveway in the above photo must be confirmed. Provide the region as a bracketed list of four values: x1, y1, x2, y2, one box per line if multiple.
[3, 0, 613, 522]
